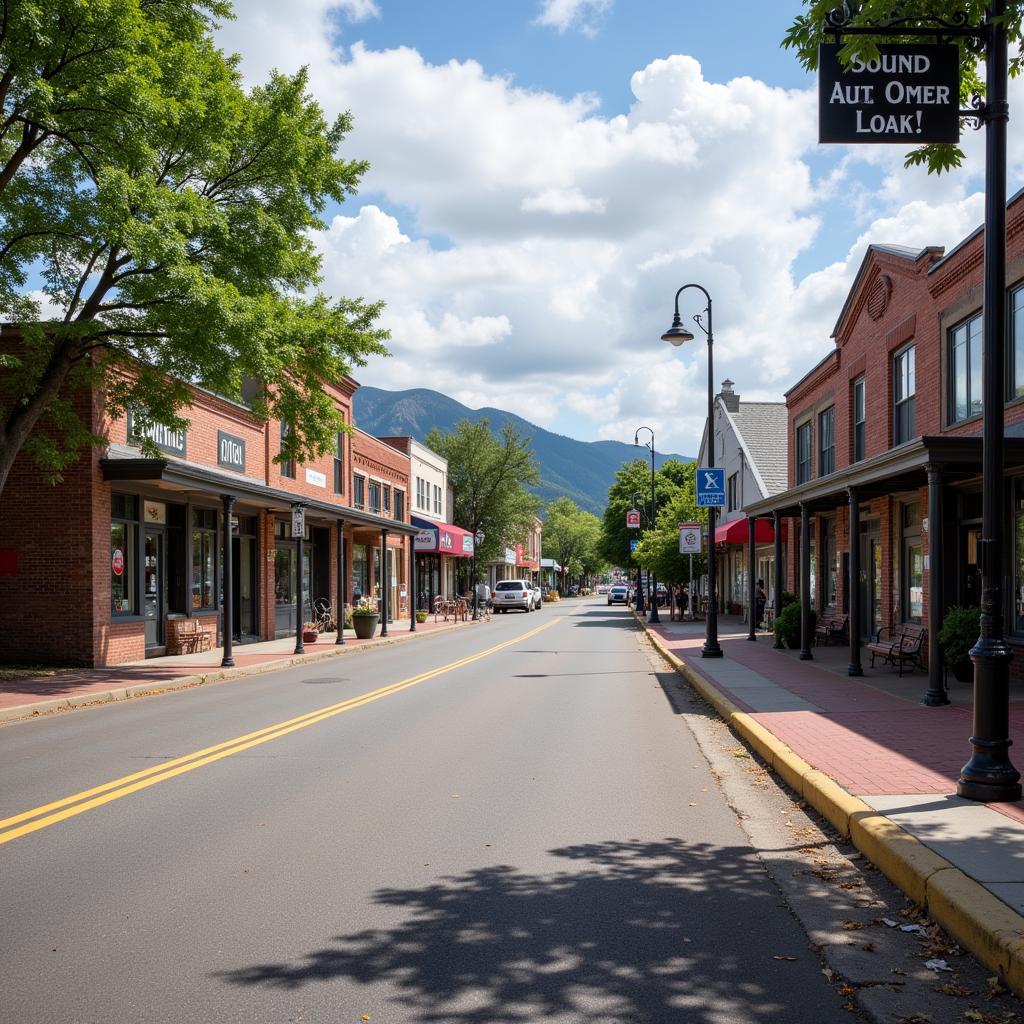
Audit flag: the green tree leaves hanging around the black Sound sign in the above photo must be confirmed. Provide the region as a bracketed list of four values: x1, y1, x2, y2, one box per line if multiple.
[782, 0, 1024, 173]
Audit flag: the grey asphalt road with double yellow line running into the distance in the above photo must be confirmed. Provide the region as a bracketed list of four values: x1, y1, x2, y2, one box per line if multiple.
[0, 601, 850, 1024]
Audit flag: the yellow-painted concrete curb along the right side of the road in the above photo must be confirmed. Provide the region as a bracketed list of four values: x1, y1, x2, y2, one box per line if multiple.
[638, 618, 1024, 995]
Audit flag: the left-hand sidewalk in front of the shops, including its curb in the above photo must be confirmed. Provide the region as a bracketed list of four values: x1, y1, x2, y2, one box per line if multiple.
[0, 616, 479, 722]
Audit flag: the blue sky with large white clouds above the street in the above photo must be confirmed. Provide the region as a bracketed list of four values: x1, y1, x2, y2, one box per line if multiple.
[32, 0, 1024, 455]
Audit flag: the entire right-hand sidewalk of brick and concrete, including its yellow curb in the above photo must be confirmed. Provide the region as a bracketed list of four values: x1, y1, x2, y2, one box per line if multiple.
[643, 620, 1024, 994]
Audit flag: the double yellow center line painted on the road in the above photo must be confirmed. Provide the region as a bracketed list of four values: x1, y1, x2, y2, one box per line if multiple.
[0, 616, 564, 846]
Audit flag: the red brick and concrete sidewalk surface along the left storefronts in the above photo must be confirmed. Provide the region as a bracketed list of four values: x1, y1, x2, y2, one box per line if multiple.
[0, 618, 467, 715]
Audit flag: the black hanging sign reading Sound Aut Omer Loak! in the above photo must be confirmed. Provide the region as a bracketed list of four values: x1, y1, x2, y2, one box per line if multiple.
[818, 43, 959, 145]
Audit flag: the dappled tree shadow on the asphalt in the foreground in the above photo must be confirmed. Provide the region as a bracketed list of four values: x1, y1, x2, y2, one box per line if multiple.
[217, 838, 843, 1024]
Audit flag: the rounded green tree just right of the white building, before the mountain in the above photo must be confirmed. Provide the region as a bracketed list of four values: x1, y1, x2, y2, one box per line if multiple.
[426, 419, 541, 561]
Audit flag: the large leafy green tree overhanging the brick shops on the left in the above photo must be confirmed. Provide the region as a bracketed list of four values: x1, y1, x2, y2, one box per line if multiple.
[0, 0, 387, 490]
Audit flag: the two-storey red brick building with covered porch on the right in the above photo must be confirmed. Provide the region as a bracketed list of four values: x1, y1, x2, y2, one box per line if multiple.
[744, 193, 1024, 689]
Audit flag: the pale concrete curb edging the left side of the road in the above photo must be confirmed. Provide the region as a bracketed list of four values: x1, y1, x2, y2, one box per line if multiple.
[0, 621, 481, 725]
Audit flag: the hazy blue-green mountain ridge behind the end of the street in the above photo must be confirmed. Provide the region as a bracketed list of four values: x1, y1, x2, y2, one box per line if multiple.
[354, 387, 690, 515]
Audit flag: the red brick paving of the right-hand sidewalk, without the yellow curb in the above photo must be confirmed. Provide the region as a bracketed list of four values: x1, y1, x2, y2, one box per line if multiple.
[647, 624, 1024, 822]
